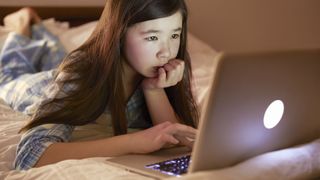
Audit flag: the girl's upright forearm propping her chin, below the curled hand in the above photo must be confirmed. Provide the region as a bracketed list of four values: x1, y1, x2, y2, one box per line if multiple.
[143, 89, 179, 125]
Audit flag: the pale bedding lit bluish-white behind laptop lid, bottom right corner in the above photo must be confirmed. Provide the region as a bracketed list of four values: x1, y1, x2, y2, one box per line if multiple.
[172, 139, 320, 180]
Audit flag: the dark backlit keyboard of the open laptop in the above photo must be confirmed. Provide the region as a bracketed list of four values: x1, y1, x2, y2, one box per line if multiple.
[145, 155, 190, 176]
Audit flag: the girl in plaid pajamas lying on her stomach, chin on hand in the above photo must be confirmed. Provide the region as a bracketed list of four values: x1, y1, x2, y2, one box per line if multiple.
[0, 0, 198, 169]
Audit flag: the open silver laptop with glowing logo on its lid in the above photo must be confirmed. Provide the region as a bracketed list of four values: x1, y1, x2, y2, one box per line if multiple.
[107, 49, 320, 178]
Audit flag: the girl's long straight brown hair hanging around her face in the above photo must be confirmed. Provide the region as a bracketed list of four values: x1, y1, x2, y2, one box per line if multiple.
[22, 0, 198, 135]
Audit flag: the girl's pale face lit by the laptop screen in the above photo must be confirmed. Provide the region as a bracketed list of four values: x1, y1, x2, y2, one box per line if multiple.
[124, 12, 182, 77]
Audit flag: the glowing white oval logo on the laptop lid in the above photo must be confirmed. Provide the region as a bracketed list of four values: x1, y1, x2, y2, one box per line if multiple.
[263, 100, 284, 129]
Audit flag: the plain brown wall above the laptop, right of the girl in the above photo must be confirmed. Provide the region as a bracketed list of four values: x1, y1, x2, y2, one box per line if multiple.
[186, 0, 320, 51]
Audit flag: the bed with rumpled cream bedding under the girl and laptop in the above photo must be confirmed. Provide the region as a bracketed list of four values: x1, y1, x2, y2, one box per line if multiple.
[0, 11, 320, 180]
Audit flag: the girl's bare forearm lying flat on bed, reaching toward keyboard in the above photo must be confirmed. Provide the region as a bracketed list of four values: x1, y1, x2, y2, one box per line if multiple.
[35, 134, 134, 167]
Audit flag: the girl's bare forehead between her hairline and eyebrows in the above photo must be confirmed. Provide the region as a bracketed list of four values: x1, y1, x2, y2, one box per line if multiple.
[132, 11, 182, 31]
